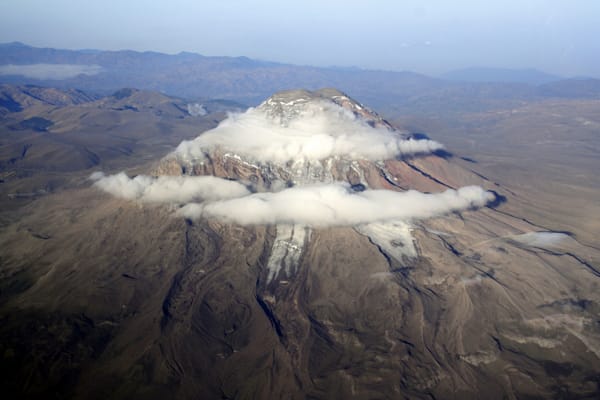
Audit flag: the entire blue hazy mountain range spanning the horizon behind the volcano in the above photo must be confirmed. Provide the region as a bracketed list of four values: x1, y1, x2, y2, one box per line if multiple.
[0, 43, 600, 113]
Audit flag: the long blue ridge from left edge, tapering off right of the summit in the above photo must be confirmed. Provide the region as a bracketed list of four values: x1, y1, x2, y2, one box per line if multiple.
[0, 43, 437, 103]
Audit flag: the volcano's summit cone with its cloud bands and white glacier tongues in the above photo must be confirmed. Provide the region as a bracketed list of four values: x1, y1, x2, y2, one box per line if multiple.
[92, 89, 494, 282]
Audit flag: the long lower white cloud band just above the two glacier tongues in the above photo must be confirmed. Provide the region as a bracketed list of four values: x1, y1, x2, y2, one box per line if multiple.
[178, 183, 494, 227]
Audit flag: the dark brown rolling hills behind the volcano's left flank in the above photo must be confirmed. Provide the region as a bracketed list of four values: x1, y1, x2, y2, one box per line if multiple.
[0, 85, 225, 216]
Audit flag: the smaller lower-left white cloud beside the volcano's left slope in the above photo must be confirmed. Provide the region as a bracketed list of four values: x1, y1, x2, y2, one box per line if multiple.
[90, 172, 250, 203]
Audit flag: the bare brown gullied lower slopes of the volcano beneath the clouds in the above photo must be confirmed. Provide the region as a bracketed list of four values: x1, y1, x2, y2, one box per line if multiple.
[0, 89, 600, 399]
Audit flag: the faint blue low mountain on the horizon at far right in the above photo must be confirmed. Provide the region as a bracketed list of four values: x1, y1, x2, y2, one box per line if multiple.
[442, 67, 562, 85]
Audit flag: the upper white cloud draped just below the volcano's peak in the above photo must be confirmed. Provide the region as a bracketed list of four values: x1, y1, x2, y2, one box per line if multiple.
[175, 102, 443, 163]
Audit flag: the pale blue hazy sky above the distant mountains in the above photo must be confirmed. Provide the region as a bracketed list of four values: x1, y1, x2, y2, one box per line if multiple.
[0, 0, 600, 76]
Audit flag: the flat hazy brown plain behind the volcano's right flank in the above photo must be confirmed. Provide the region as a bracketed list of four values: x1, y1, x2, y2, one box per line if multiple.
[394, 99, 600, 246]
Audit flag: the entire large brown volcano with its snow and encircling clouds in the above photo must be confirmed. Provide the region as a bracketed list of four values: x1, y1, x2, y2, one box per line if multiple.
[0, 89, 600, 399]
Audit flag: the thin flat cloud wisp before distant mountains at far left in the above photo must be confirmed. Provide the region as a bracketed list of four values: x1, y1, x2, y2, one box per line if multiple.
[0, 64, 103, 80]
